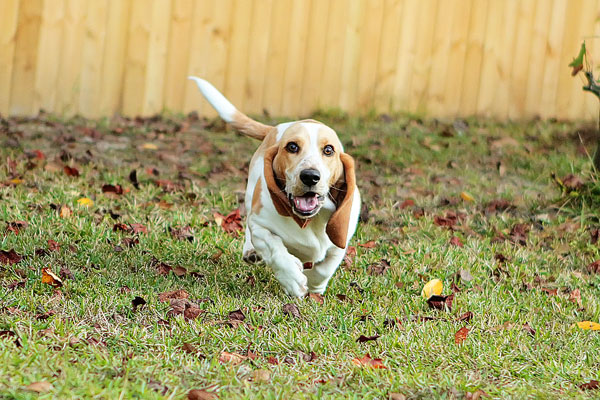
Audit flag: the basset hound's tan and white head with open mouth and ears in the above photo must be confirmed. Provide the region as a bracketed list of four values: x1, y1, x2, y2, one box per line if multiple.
[265, 121, 355, 248]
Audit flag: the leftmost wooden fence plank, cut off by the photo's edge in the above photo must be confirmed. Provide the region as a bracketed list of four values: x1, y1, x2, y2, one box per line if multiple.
[0, 0, 19, 114]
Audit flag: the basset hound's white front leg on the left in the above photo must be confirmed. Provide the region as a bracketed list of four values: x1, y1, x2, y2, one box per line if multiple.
[248, 217, 307, 297]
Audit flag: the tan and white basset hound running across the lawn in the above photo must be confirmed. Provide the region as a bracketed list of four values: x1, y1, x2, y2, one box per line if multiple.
[189, 77, 361, 297]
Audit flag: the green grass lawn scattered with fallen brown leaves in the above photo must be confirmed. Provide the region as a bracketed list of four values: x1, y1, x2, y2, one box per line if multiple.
[0, 113, 600, 399]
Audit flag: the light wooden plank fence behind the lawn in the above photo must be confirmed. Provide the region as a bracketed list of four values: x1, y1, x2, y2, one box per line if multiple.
[0, 0, 600, 119]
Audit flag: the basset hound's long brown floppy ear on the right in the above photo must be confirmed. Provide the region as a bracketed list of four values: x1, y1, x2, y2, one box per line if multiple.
[326, 153, 356, 249]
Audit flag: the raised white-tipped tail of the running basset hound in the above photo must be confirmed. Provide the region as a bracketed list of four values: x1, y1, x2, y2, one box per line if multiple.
[188, 76, 272, 140]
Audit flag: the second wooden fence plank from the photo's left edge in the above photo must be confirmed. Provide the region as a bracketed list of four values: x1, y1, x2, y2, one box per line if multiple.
[9, 0, 43, 115]
